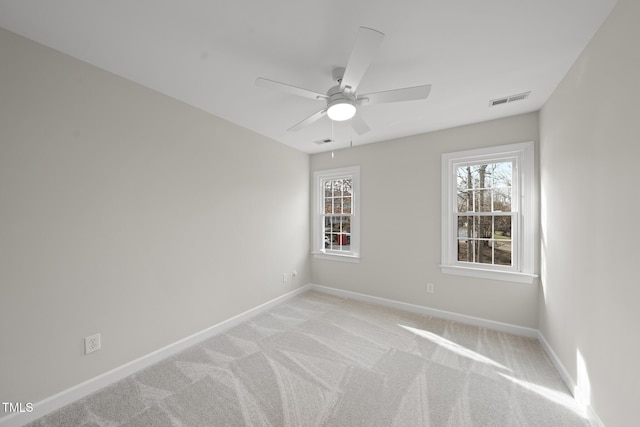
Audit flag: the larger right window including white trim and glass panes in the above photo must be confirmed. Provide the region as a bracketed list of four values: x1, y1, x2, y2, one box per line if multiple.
[441, 142, 536, 283]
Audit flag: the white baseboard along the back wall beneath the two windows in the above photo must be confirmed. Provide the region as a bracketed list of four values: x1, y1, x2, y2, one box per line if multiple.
[311, 284, 539, 338]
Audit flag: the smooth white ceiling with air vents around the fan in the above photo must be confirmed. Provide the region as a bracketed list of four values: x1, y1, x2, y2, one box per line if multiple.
[0, 0, 617, 153]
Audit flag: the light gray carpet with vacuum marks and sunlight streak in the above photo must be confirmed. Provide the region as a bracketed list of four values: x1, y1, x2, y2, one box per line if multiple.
[30, 292, 589, 427]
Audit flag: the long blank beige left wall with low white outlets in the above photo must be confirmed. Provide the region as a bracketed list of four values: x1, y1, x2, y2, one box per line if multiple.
[0, 30, 310, 410]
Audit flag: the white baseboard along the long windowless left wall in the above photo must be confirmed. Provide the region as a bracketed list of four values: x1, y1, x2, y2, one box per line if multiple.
[0, 285, 311, 427]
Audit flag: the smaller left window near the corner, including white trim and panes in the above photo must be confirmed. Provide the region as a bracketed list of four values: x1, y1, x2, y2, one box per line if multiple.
[313, 166, 360, 262]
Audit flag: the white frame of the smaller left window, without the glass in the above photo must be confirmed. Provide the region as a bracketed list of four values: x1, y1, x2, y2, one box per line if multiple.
[311, 166, 360, 262]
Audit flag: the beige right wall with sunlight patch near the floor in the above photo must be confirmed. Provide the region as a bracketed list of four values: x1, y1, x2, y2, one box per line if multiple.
[540, 0, 640, 427]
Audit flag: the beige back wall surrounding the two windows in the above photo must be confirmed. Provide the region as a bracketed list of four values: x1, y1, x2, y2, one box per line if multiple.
[311, 113, 539, 328]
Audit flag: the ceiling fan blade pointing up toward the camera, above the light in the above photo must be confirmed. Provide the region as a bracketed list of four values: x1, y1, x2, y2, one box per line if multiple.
[340, 27, 384, 93]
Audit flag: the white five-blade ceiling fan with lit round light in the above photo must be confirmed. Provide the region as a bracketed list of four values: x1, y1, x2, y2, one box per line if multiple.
[256, 27, 431, 135]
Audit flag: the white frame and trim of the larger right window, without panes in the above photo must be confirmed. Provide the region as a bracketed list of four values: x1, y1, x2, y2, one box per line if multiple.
[440, 142, 538, 283]
